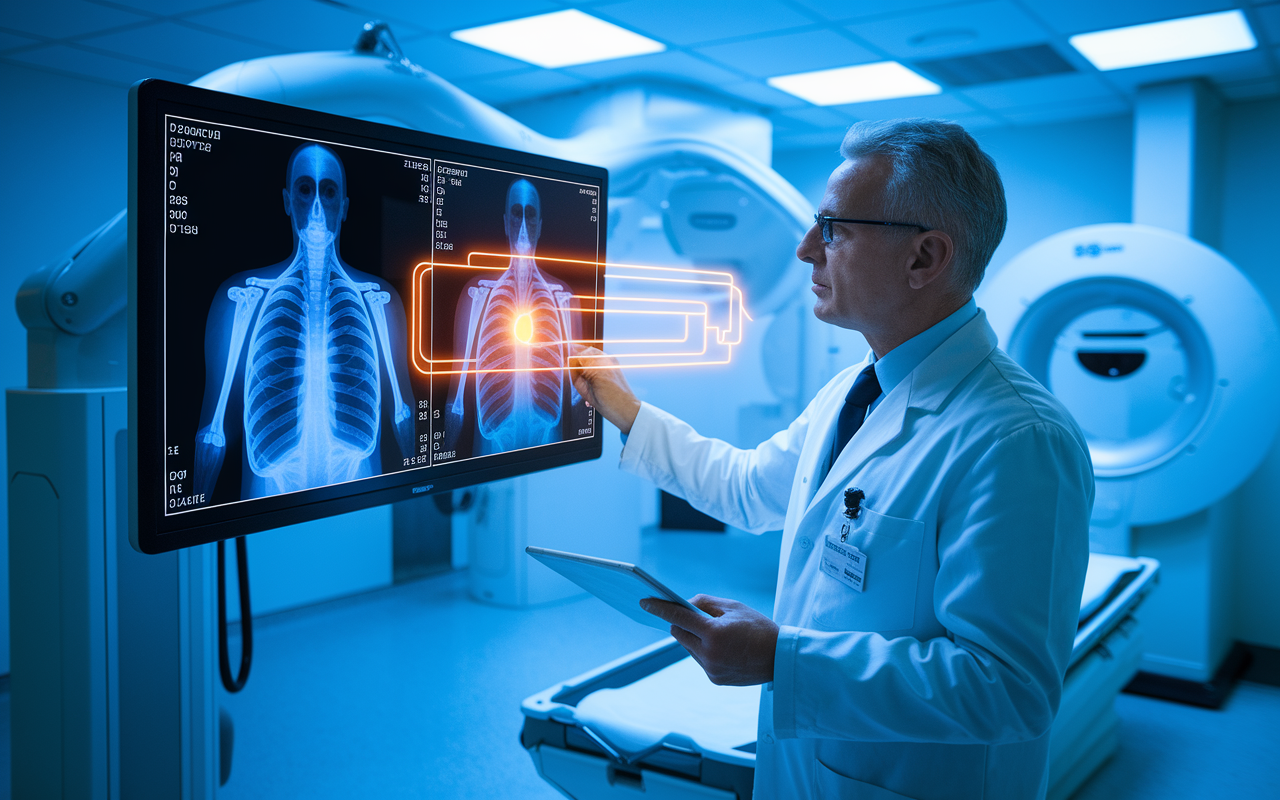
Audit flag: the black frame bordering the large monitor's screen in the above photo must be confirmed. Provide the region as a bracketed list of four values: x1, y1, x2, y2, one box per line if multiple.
[122, 79, 609, 554]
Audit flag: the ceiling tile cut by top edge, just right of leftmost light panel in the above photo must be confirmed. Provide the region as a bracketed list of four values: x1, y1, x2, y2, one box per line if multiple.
[591, 0, 813, 45]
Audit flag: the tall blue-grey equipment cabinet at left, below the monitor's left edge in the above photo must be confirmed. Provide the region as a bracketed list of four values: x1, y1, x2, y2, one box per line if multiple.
[6, 388, 221, 800]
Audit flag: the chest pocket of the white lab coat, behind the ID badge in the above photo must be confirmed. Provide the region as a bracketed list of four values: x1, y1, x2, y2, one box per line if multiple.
[813, 508, 924, 631]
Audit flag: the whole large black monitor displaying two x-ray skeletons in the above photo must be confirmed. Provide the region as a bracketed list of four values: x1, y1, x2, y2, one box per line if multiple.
[129, 81, 608, 553]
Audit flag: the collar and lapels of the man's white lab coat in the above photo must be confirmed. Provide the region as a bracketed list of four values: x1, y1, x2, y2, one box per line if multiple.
[805, 310, 997, 512]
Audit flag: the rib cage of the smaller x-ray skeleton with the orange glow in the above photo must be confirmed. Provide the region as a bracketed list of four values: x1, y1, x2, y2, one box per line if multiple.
[476, 259, 568, 440]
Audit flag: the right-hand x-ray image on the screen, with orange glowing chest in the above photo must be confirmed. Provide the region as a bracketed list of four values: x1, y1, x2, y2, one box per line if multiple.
[438, 170, 595, 457]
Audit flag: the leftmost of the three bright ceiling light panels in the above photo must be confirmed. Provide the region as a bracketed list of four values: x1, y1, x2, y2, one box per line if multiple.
[449, 9, 667, 69]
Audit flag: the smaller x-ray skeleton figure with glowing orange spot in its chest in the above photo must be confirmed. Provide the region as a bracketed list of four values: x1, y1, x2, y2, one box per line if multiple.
[448, 178, 581, 454]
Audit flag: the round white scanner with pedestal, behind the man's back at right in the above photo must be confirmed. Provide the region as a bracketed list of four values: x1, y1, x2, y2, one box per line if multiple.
[979, 224, 1280, 682]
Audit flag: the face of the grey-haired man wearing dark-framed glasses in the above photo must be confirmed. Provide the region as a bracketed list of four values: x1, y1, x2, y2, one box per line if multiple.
[796, 157, 916, 335]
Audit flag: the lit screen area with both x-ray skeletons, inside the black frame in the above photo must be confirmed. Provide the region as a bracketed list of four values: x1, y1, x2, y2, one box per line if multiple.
[155, 112, 603, 518]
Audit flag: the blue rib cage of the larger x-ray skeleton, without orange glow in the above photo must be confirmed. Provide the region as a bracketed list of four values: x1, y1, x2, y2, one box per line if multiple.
[244, 253, 381, 490]
